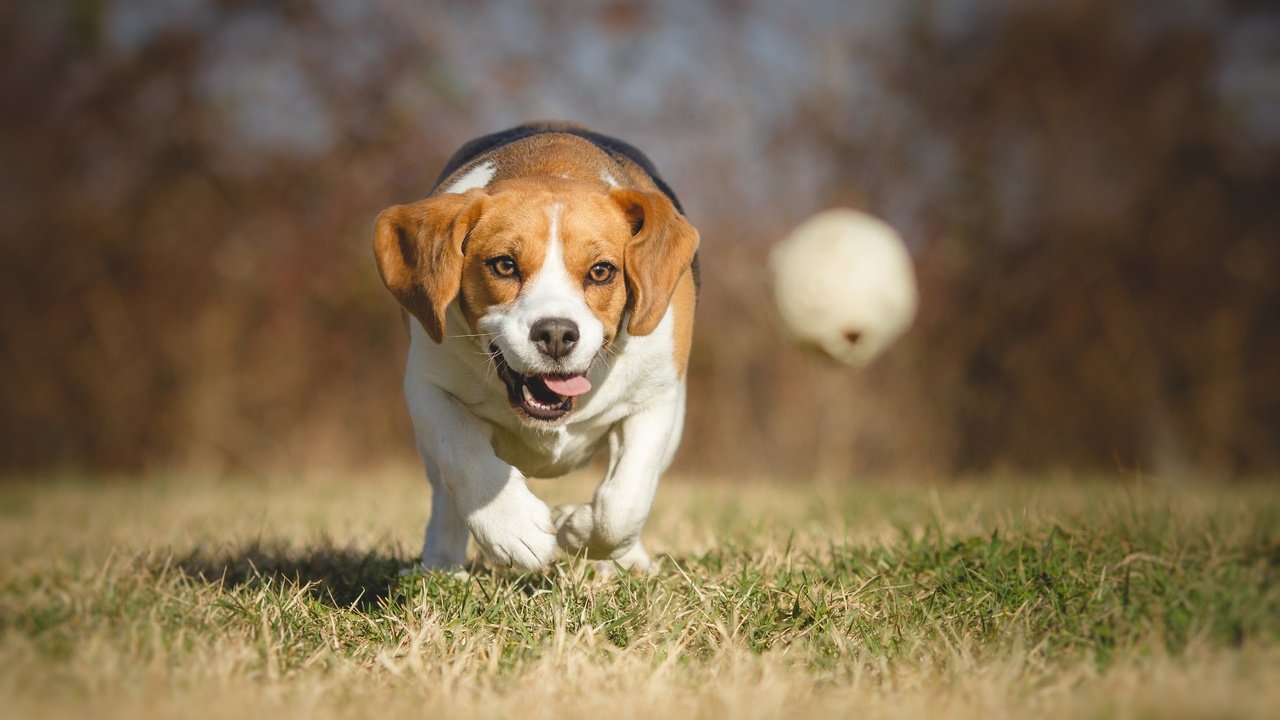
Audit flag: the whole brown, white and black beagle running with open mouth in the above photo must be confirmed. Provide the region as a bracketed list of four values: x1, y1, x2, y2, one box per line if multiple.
[374, 123, 698, 570]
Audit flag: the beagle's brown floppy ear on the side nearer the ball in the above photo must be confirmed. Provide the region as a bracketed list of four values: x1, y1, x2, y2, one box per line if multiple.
[609, 188, 698, 336]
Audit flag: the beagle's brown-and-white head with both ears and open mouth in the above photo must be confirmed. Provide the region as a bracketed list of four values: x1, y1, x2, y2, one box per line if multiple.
[374, 178, 698, 423]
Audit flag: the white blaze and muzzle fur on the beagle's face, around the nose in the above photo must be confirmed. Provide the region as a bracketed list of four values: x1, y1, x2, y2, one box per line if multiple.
[480, 202, 604, 374]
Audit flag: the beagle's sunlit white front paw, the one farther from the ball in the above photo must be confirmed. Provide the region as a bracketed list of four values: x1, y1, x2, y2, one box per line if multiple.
[467, 486, 556, 570]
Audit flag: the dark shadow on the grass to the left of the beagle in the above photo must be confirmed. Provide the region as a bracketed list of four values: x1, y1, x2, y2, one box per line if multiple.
[172, 541, 412, 609]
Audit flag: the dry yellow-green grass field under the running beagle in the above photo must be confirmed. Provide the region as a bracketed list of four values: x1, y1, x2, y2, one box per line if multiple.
[0, 470, 1280, 720]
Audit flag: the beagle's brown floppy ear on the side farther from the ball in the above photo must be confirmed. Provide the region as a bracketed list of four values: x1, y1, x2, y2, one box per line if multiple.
[374, 190, 486, 342]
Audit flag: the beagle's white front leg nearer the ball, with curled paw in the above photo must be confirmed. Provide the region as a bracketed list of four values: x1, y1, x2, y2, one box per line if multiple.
[556, 391, 684, 570]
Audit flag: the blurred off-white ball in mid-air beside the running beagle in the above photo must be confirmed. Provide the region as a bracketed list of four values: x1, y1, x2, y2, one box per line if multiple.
[769, 209, 915, 365]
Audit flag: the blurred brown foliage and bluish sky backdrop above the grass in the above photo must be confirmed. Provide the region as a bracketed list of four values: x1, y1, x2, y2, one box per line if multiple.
[0, 0, 1280, 478]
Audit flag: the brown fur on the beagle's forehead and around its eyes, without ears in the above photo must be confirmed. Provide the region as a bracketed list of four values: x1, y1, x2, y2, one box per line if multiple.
[460, 178, 631, 342]
